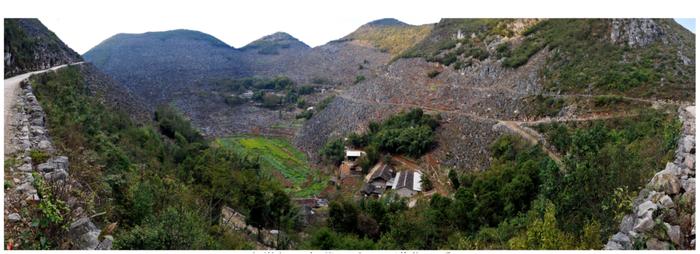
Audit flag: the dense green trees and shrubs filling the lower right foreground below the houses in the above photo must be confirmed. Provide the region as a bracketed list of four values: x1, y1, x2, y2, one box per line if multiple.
[308, 107, 680, 249]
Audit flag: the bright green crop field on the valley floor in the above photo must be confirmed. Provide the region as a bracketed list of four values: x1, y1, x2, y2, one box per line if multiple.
[215, 136, 328, 197]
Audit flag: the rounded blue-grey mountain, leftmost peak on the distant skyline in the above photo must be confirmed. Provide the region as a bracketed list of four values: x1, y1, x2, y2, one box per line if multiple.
[83, 30, 246, 106]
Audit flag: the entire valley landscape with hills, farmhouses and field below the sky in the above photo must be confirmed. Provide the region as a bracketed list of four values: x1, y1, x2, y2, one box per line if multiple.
[5, 19, 696, 250]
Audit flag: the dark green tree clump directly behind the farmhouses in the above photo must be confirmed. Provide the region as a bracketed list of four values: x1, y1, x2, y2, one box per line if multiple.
[320, 108, 440, 169]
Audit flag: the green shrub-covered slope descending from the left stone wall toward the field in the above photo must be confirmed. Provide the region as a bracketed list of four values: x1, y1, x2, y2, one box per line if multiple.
[28, 67, 298, 249]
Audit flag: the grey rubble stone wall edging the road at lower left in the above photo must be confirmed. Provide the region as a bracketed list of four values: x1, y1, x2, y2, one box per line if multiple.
[5, 76, 112, 250]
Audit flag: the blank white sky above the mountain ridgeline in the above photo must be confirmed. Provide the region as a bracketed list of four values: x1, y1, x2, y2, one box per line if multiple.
[2, 0, 697, 54]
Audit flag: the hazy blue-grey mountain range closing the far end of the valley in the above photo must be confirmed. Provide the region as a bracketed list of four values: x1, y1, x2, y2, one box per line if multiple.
[84, 27, 391, 136]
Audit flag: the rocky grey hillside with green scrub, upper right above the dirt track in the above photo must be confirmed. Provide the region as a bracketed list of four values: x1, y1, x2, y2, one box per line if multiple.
[295, 19, 695, 169]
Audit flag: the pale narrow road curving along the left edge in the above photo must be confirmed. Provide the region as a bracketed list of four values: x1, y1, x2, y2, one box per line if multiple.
[4, 62, 83, 154]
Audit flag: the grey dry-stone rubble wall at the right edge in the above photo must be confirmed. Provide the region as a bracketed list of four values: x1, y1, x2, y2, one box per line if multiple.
[605, 106, 695, 250]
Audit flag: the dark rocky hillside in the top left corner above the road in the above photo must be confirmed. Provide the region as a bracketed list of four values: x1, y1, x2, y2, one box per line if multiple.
[4, 19, 82, 78]
